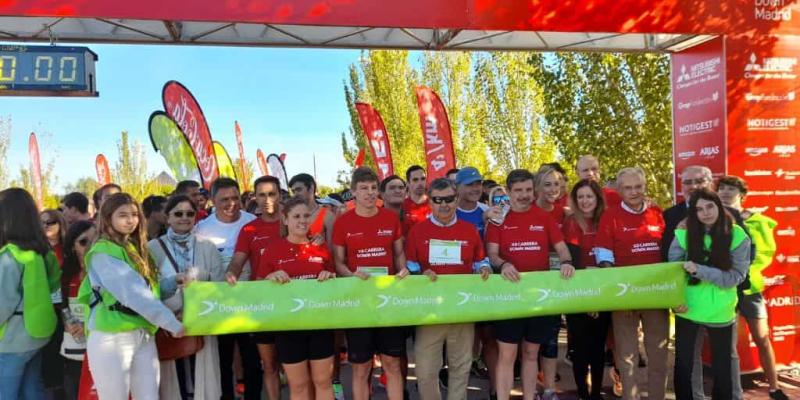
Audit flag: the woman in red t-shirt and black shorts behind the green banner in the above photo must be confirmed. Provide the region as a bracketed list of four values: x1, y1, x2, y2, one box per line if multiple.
[255, 197, 336, 400]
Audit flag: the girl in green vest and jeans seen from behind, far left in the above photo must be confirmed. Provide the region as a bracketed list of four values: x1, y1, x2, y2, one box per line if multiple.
[0, 188, 61, 400]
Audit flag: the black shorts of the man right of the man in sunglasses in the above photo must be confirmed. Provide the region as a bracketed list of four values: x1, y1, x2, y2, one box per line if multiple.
[494, 315, 561, 350]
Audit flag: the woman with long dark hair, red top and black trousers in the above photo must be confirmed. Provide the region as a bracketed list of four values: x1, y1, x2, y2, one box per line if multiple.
[563, 179, 611, 399]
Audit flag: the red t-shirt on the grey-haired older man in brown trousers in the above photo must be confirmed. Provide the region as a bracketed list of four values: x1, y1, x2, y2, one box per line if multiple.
[597, 206, 664, 266]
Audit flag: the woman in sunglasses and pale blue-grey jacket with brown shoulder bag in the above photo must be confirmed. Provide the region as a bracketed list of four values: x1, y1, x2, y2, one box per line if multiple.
[147, 195, 225, 399]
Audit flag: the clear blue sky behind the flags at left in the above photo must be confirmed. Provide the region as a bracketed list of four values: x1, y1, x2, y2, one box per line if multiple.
[0, 45, 360, 190]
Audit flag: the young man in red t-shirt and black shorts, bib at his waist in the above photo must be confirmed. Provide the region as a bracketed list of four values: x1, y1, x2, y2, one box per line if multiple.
[333, 167, 408, 400]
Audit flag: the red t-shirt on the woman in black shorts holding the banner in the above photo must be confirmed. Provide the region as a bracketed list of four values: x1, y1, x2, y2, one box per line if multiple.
[255, 239, 333, 280]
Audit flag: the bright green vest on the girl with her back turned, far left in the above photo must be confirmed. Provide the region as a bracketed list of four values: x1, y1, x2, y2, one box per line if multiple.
[0, 243, 61, 339]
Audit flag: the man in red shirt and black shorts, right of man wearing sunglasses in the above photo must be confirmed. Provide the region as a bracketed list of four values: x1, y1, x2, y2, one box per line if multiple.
[486, 169, 575, 400]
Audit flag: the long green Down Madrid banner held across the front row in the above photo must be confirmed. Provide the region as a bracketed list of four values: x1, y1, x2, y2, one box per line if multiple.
[183, 263, 686, 335]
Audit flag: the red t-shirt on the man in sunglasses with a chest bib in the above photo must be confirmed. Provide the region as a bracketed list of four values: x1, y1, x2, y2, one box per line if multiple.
[406, 219, 486, 275]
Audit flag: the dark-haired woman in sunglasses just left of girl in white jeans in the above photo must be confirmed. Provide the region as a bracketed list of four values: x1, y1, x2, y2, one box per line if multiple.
[61, 221, 96, 400]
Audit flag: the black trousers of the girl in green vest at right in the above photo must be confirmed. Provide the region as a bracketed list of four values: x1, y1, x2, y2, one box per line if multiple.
[675, 317, 734, 400]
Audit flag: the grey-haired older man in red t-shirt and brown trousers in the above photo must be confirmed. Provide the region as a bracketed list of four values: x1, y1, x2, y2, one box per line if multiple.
[594, 168, 669, 400]
